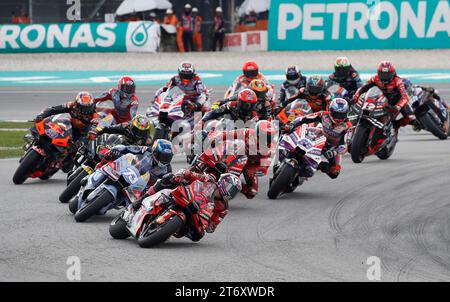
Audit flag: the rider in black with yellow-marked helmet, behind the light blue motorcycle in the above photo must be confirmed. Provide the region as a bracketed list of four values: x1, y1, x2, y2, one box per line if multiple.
[90, 114, 152, 146]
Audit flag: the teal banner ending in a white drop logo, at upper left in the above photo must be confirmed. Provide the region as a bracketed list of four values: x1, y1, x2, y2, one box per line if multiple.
[0, 21, 161, 53]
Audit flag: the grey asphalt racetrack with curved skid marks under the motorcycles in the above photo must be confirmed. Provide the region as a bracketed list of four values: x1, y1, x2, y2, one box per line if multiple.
[0, 85, 450, 281]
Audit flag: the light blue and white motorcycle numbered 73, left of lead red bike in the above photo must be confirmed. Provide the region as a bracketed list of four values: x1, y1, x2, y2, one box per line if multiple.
[69, 153, 150, 222]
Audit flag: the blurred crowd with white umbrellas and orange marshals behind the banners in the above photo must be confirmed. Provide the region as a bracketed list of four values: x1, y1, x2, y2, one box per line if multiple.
[0, 0, 270, 52]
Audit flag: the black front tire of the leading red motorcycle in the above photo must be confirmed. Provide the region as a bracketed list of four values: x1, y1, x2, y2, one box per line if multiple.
[138, 215, 184, 248]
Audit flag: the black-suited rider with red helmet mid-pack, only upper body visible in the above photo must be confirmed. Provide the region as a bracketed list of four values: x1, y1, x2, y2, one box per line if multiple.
[202, 89, 258, 123]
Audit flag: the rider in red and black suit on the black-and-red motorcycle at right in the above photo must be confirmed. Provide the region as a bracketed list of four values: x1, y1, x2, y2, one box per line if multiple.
[353, 61, 417, 130]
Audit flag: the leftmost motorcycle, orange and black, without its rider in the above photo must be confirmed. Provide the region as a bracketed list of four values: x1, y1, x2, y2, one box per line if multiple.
[13, 114, 72, 184]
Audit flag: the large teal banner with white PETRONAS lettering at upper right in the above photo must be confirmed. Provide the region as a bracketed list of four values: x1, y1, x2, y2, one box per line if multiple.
[269, 0, 450, 50]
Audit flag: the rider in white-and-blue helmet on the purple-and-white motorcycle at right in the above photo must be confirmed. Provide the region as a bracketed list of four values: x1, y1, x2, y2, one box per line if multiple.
[285, 98, 352, 179]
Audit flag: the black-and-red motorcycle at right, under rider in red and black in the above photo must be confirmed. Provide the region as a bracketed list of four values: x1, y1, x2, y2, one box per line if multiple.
[349, 87, 398, 163]
